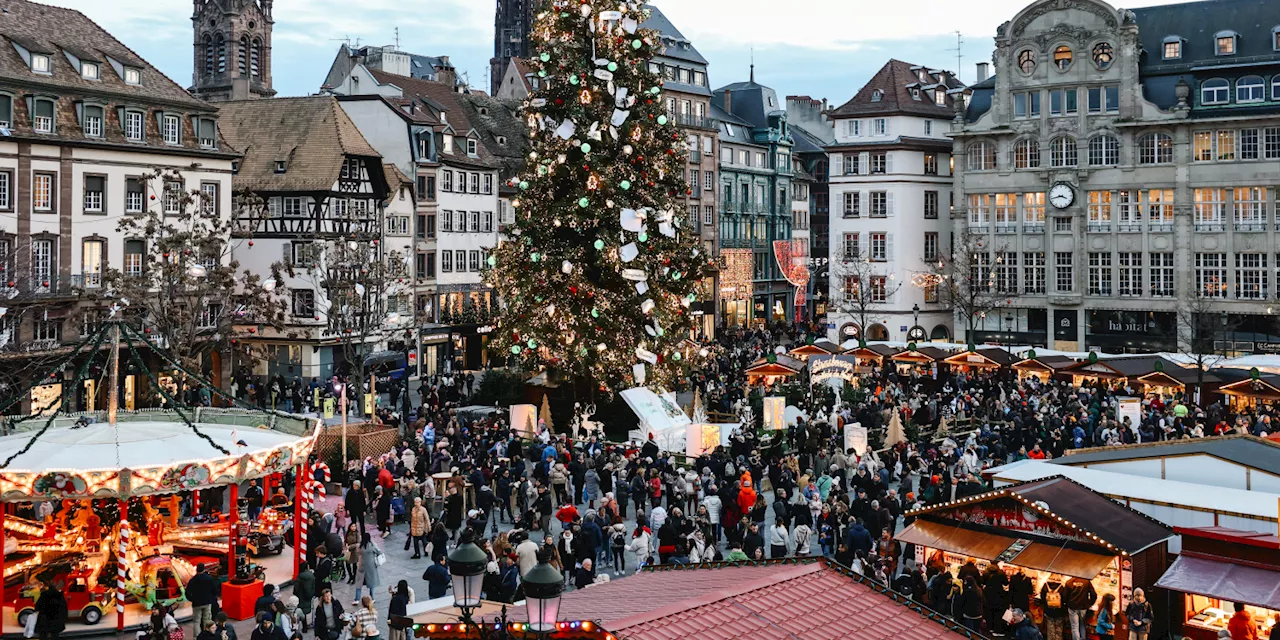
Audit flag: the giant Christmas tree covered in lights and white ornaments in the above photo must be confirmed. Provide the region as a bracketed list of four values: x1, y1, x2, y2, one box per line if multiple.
[489, 0, 713, 393]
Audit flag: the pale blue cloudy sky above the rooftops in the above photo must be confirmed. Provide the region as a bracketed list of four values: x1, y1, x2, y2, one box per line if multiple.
[45, 0, 1187, 104]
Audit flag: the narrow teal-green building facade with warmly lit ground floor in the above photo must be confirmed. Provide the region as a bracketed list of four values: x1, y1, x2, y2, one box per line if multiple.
[712, 72, 795, 326]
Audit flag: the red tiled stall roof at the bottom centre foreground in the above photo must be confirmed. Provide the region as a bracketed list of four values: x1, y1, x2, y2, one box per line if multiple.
[486, 558, 965, 640]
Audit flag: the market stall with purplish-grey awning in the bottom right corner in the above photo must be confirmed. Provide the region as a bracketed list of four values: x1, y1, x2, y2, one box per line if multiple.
[1156, 527, 1280, 640]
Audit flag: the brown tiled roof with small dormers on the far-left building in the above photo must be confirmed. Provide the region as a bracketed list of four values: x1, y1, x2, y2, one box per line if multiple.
[0, 0, 207, 113]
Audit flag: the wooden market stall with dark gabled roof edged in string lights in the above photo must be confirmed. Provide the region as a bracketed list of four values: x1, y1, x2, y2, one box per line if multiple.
[896, 476, 1172, 637]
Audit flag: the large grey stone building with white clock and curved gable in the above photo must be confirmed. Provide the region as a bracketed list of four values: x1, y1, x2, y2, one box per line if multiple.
[952, 0, 1280, 353]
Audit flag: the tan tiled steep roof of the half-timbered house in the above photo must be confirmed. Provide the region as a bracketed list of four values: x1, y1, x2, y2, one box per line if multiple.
[219, 96, 381, 192]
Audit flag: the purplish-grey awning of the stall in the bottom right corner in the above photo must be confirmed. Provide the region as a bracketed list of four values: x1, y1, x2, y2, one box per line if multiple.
[1156, 553, 1280, 611]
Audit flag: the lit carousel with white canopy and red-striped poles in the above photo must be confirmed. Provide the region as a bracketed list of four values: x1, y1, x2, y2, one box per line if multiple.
[0, 323, 323, 634]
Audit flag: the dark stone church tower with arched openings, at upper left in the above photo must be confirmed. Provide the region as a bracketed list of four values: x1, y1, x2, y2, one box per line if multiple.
[189, 0, 275, 102]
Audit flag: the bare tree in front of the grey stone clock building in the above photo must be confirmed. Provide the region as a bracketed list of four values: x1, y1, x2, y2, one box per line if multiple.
[915, 229, 1018, 344]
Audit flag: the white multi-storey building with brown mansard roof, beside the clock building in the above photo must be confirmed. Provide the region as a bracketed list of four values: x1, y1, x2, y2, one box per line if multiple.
[826, 60, 964, 343]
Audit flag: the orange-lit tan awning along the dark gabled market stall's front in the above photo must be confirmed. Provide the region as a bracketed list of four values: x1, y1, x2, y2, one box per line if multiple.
[897, 520, 1114, 580]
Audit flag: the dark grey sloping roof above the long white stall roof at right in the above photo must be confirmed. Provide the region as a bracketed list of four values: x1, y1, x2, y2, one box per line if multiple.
[1056, 435, 1280, 475]
